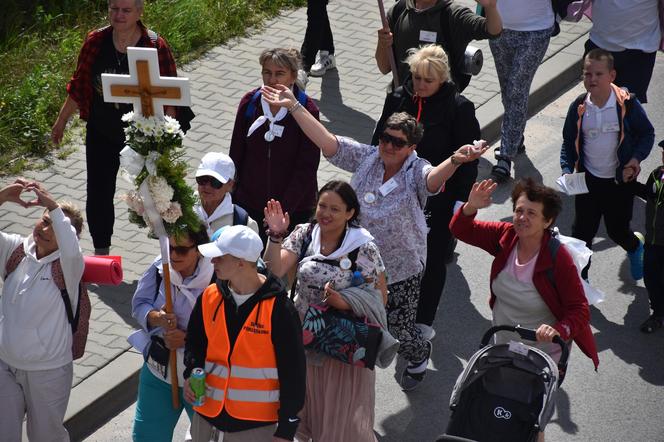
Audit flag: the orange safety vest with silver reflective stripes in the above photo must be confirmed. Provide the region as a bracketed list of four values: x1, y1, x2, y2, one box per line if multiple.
[194, 285, 279, 422]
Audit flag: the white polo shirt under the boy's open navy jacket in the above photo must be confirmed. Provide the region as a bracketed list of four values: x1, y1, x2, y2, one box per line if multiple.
[581, 90, 620, 178]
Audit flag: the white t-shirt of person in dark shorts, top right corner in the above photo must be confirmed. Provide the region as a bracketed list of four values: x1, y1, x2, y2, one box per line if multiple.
[588, 0, 661, 52]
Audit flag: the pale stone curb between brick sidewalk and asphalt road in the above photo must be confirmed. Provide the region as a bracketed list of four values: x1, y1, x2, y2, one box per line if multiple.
[64, 33, 588, 441]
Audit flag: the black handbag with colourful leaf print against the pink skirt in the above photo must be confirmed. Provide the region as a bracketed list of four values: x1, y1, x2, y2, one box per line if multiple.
[302, 304, 383, 370]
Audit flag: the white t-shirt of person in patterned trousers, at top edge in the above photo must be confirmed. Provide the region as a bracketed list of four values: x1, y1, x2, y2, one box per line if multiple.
[496, 0, 556, 31]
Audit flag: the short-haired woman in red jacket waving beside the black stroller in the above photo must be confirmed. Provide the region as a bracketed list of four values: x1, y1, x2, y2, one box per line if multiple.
[450, 178, 599, 369]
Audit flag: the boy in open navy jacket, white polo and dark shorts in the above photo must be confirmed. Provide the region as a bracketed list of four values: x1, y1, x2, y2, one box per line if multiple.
[560, 49, 655, 280]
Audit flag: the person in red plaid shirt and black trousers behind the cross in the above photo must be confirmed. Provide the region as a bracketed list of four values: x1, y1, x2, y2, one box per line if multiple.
[51, 0, 182, 255]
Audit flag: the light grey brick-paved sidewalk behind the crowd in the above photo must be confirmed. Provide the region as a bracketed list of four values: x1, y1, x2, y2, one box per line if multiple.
[0, 0, 588, 394]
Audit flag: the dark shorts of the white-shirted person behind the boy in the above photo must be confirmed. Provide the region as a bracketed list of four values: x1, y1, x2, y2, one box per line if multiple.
[583, 40, 657, 103]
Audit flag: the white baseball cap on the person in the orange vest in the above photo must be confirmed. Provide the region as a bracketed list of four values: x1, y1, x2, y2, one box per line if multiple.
[198, 225, 263, 262]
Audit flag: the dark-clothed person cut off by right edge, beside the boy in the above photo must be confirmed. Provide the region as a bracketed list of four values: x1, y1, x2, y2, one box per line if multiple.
[637, 140, 664, 333]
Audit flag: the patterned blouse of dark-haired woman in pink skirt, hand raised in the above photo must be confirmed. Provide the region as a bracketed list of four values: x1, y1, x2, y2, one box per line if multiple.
[282, 223, 385, 317]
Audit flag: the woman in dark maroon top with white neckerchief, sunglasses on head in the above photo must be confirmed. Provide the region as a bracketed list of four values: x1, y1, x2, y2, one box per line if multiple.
[230, 48, 320, 244]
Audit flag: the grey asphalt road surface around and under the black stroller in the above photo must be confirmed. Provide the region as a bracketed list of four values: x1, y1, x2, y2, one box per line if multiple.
[88, 54, 664, 442]
